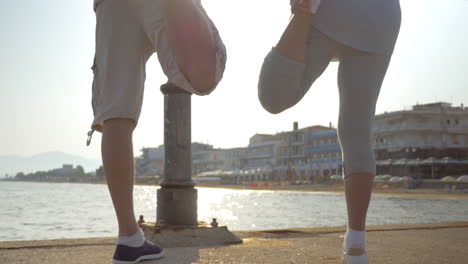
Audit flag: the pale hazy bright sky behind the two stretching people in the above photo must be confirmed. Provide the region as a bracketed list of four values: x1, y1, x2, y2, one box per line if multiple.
[0, 0, 468, 160]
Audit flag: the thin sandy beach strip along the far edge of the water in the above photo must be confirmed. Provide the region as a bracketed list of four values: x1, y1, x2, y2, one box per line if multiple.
[1, 179, 468, 199]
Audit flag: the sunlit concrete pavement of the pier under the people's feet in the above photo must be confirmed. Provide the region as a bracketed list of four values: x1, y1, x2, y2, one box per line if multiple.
[0, 222, 468, 264]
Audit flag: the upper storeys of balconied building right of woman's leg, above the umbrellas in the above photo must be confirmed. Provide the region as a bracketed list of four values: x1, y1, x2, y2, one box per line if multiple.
[374, 103, 468, 159]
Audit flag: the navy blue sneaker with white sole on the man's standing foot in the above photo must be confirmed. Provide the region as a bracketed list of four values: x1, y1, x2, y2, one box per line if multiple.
[112, 241, 164, 264]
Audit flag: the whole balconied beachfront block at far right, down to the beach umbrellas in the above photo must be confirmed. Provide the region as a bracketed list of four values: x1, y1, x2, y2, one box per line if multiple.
[373, 102, 468, 178]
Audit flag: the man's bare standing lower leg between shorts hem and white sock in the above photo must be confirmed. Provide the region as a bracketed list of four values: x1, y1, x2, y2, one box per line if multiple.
[101, 119, 138, 236]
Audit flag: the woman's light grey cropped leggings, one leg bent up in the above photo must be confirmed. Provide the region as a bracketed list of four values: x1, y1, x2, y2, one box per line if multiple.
[258, 27, 391, 178]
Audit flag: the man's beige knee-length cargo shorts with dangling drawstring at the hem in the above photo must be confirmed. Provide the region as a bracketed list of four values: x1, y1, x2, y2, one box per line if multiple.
[87, 0, 226, 145]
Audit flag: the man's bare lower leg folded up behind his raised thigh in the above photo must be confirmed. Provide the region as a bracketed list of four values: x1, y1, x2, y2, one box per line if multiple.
[166, 0, 217, 93]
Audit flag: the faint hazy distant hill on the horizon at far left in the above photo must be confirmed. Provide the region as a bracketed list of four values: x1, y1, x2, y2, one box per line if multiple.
[0, 152, 101, 178]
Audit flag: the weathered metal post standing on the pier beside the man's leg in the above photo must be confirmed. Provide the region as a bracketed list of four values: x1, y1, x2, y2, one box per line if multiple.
[156, 83, 198, 226]
